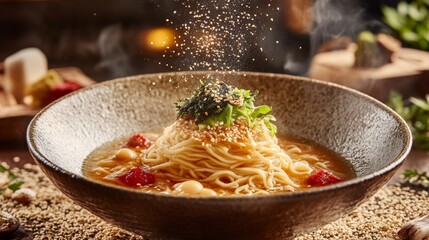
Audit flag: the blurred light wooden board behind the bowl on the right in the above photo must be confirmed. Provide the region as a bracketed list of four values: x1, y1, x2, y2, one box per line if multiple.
[309, 45, 429, 101]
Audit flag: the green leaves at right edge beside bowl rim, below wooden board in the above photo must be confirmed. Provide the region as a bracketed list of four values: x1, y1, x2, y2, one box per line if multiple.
[387, 92, 429, 150]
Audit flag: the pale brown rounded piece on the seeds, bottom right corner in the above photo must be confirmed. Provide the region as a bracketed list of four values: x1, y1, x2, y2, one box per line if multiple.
[398, 215, 429, 240]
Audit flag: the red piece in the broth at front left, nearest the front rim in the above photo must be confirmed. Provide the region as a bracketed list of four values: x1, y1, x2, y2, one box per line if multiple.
[118, 167, 155, 187]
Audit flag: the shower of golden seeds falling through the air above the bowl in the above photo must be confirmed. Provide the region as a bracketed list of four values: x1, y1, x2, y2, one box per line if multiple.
[162, 0, 279, 71]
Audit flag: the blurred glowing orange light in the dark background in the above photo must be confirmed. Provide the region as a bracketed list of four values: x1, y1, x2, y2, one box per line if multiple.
[141, 28, 176, 51]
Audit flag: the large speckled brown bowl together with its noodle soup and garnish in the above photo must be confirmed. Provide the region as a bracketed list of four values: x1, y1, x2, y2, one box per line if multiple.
[28, 72, 411, 239]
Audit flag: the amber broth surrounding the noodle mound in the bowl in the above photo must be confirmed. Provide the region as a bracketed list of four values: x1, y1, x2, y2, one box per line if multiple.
[82, 131, 355, 196]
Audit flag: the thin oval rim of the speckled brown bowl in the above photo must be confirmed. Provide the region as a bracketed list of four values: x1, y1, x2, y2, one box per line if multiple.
[26, 71, 412, 203]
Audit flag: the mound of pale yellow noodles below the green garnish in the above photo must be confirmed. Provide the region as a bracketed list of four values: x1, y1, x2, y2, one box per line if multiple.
[142, 120, 312, 194]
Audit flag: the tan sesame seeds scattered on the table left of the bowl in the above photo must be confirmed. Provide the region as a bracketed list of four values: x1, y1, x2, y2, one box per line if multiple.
[0, 164, 143, 240]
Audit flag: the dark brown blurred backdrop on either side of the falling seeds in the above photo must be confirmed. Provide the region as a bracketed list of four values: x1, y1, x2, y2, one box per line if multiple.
[0, 0, 408, 81]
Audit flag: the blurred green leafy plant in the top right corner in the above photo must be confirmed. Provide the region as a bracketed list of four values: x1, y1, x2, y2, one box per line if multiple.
[381, 0, 429, 50]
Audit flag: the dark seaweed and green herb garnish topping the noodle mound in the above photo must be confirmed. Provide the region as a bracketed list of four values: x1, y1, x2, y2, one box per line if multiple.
[176, 82, 277, 135]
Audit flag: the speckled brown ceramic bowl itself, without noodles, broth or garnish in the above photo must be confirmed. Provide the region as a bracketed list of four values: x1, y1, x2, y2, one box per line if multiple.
[28, 73, 410, 239]
